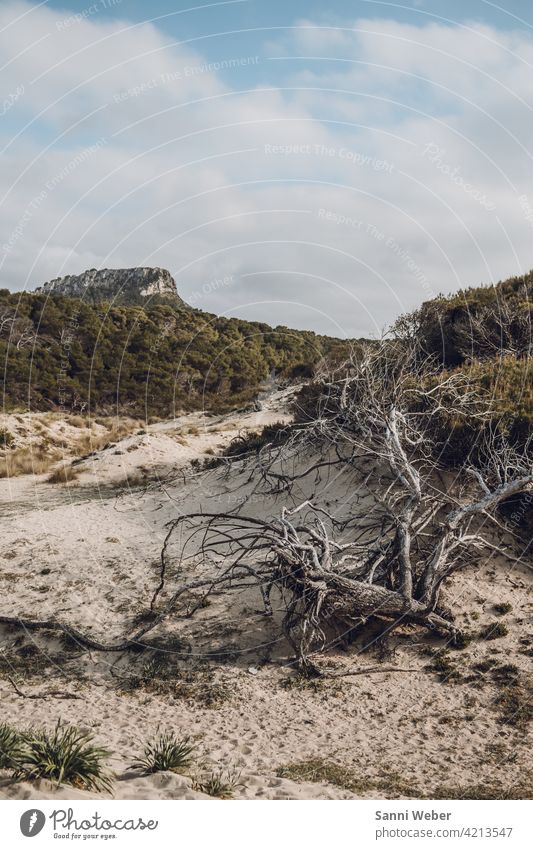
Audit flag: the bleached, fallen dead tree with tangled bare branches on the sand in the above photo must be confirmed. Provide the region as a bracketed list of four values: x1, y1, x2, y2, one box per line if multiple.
[162, 341, 533, 668]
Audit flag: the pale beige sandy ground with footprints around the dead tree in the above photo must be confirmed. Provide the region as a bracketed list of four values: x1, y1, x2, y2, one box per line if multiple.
[0, 392, 531, 799]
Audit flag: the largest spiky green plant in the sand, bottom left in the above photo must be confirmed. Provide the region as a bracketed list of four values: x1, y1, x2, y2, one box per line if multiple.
[14, 723, 112, 792]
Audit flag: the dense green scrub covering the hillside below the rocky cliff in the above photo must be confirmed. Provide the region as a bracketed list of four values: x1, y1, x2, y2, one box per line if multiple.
[0, 290, 345, 416]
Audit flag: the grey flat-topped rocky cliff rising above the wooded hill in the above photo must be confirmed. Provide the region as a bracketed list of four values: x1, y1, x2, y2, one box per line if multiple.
[36, 268, 185, 306]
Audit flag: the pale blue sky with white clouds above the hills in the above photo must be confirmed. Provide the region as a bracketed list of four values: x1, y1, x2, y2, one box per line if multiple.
[0, 0, 533, 336]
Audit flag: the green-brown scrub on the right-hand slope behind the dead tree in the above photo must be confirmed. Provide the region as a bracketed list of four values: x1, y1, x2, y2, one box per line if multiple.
[295, 272, 533, 458]
